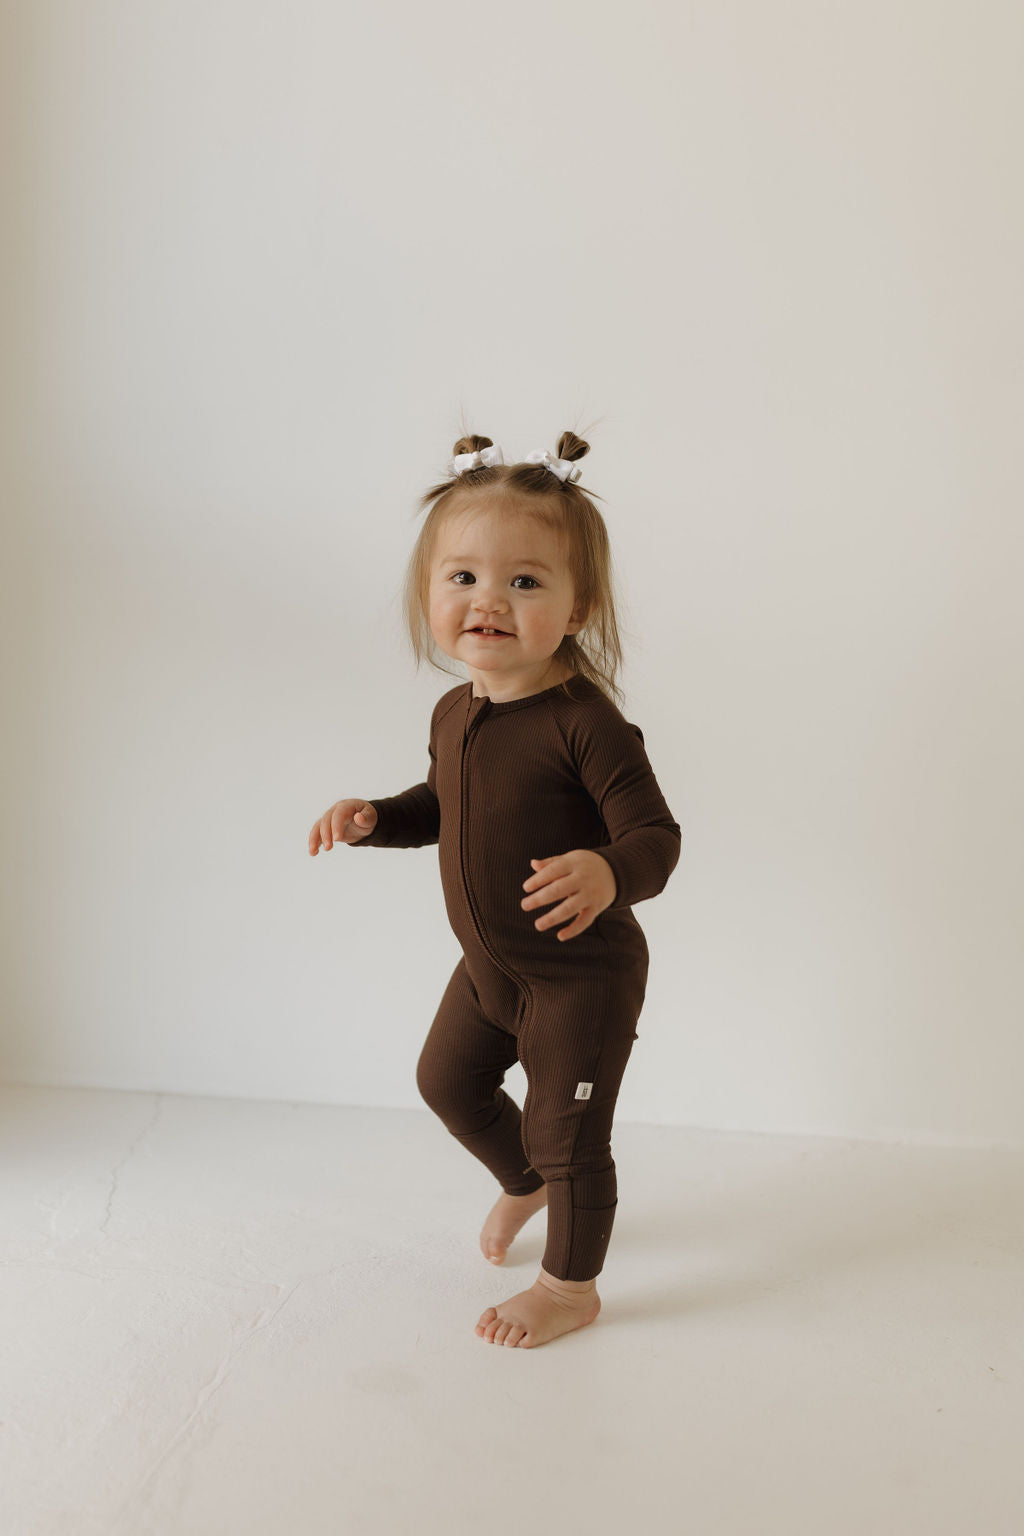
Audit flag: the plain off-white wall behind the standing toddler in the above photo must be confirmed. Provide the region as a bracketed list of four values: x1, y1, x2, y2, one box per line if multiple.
[0, 0, 1024, 1143]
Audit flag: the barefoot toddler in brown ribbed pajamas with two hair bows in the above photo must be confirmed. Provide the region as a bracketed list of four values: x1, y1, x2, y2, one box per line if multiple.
[309, 432, 680, 1349]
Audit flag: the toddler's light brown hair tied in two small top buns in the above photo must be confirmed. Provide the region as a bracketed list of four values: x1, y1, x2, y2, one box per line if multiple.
[402, 432, 623, 707]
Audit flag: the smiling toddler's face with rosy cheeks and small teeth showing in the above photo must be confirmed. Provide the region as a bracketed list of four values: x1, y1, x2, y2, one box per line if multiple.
[430, 505, 582, 691]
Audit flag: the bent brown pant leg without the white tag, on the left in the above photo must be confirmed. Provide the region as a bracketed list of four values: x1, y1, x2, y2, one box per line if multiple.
[416, 957, 543, 1195]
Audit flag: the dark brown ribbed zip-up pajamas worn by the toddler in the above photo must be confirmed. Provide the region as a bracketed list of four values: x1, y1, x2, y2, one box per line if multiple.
[348, 677, 680, 1281]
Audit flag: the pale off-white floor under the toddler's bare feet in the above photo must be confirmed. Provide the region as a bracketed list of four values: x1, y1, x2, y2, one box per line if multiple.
[0, 1087, 1024, 1536]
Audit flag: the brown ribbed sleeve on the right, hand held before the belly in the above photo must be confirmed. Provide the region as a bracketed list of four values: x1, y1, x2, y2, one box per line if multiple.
[571, 707, 682, 911]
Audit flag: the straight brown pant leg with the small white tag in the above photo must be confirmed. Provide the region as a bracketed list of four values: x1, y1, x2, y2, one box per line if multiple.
[519, 975, 643, 1281]
